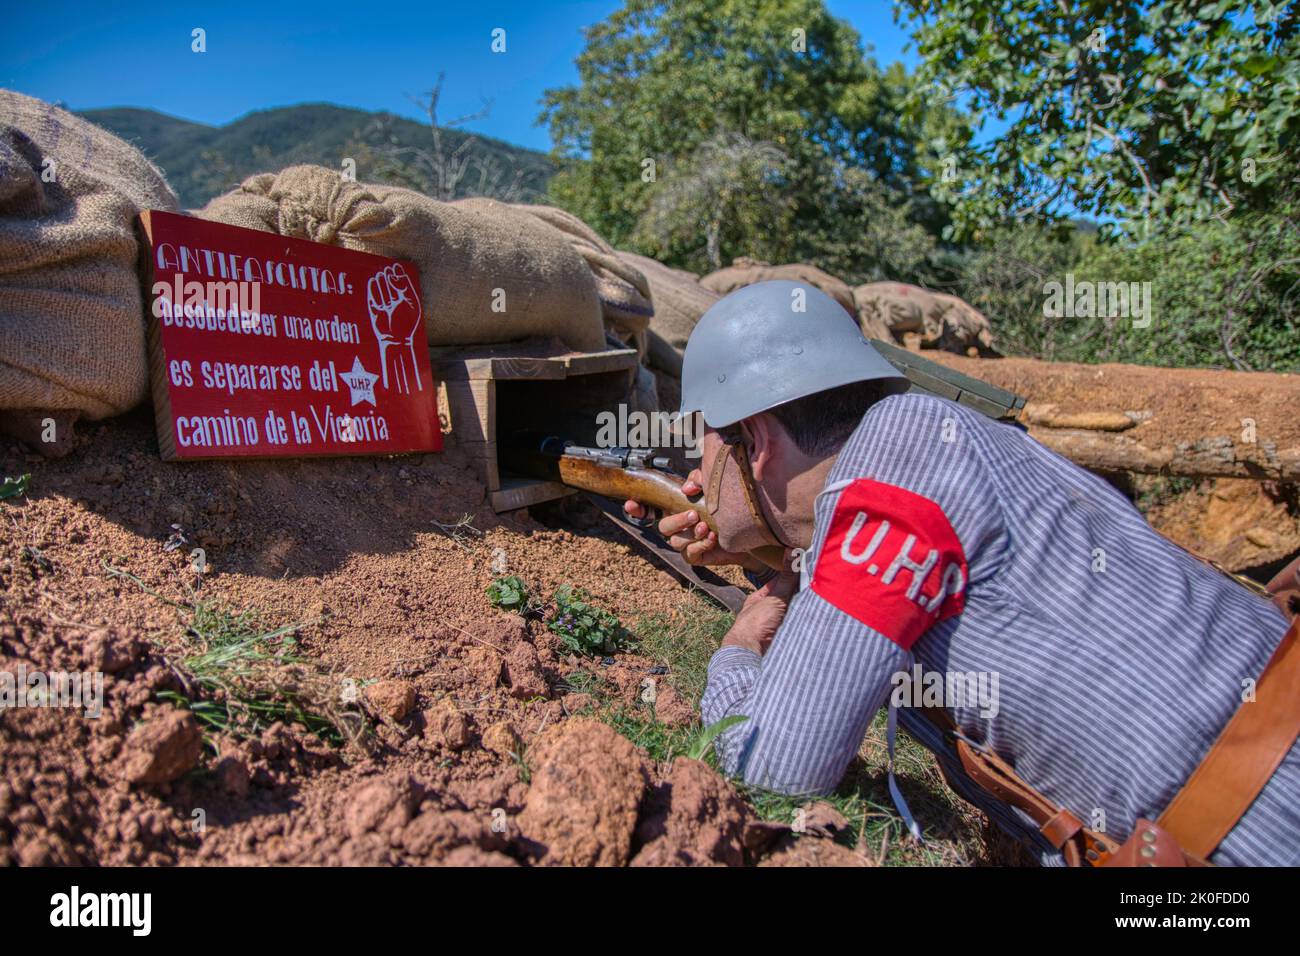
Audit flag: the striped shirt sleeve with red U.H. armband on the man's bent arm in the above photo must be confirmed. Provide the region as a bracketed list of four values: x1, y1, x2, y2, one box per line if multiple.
[701, 395, 1002, 793]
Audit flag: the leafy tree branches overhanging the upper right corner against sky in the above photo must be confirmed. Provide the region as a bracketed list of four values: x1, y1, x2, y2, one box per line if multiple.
[898, 0, 1300, 238]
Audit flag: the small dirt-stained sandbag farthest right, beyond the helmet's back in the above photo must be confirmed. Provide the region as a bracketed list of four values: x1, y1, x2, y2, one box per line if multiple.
[853, 282, 993, 355]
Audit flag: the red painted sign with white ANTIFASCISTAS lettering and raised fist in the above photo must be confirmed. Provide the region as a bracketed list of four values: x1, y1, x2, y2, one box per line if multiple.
[140, 211, 442, 459]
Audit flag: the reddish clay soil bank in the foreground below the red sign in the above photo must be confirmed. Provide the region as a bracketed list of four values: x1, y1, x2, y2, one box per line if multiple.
[0, 412, 857, 866]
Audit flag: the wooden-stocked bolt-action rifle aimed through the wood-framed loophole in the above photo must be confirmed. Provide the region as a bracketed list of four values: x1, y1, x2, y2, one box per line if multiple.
[501, 432, 785, 570]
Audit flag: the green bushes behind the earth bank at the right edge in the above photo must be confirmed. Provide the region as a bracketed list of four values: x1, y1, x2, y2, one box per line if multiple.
[948, 188, 1300, 372]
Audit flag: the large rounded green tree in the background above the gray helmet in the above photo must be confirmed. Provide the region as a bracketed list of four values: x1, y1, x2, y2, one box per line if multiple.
[542, 0, 966, 281]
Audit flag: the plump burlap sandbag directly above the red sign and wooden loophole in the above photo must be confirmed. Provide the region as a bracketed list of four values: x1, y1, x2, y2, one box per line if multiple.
[196, 165, 605, 351]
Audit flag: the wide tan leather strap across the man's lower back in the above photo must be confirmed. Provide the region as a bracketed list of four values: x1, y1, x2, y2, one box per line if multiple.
[1157, 619, 1300, 858]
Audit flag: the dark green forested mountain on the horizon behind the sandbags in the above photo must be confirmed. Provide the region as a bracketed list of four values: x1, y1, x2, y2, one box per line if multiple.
[78, 103, 555, 209]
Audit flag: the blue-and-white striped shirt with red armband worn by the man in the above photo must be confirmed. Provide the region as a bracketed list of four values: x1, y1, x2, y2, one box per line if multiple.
[701, 393, 1300, 865]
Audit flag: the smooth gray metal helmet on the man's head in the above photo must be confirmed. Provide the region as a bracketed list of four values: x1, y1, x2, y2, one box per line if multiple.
[681, 280, 907, 428]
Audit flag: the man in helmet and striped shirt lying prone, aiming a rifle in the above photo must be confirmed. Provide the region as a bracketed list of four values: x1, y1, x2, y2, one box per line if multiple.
[627, 282, 1300, 865]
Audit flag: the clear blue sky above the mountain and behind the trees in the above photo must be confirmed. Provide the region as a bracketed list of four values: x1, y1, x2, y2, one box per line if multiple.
[0, 0, 917, 150]
